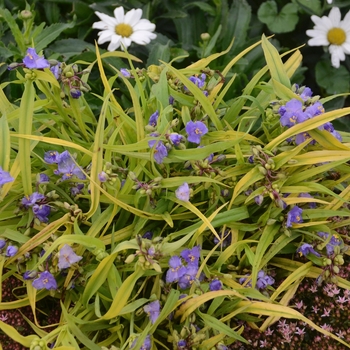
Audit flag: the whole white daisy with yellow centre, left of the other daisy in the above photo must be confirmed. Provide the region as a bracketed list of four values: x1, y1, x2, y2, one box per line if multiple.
[92, 6, 157, 51]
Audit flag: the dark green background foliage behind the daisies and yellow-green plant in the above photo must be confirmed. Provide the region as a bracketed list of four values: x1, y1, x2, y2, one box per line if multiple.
[0, 0, 350, 119]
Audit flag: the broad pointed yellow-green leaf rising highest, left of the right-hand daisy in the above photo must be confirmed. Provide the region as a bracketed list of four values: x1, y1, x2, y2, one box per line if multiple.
[261, 34, 291, 88]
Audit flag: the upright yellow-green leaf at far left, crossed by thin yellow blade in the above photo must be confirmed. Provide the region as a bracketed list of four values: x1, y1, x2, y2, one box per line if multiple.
[18, 80, 35, 196]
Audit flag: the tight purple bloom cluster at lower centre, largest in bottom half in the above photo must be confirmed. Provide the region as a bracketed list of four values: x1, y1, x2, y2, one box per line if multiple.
[165, 246, 202, 289]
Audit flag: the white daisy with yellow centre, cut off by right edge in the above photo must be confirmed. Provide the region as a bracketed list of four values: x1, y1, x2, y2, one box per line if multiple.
[306, 7, 350, 68]
